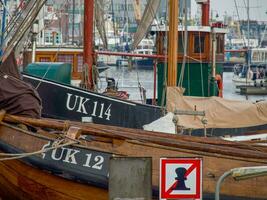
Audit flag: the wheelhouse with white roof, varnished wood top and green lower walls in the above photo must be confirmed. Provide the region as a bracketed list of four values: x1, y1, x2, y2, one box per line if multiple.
[152, 26, 227, 102]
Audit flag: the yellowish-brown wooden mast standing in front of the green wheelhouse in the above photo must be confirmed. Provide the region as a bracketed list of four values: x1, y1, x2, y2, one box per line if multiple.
[167, 0, 179, 86]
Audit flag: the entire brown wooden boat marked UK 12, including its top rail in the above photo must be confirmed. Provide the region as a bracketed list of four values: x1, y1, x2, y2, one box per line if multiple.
[0, 113, 267, 200]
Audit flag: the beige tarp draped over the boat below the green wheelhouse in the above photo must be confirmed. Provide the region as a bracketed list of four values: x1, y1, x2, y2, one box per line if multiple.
[167, 87, 267, 129]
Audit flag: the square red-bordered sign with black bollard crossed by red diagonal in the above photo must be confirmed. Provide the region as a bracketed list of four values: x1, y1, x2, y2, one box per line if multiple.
[160, 158, 202, 199]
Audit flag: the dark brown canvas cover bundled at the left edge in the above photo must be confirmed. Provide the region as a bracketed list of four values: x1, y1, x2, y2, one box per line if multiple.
[0, 53, 41, 118]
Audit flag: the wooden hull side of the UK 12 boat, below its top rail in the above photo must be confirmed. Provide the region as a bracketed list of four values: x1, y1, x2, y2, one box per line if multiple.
[0, 119, 267, 199]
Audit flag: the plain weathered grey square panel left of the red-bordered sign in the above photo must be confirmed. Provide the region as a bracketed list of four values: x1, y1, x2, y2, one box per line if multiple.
[109, 157, 152, 200]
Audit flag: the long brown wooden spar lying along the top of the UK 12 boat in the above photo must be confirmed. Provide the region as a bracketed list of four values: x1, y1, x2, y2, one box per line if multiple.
[4, 115, 267, 159]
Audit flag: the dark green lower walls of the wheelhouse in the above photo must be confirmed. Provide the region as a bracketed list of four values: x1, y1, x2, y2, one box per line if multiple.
[157, 63, 223, 105]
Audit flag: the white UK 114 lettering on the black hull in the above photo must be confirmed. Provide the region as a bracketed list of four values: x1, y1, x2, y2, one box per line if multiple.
[66, 93, 112, 120]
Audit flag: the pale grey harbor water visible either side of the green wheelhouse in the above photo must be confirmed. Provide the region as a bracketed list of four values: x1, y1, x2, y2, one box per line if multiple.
[98, 66, 267, 102]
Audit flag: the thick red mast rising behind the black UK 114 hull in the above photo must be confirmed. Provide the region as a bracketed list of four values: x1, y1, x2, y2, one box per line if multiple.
[83, 0, 94, 90]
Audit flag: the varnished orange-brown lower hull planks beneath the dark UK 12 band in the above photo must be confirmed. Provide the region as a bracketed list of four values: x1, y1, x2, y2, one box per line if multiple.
[0, 160, 108, 200]
